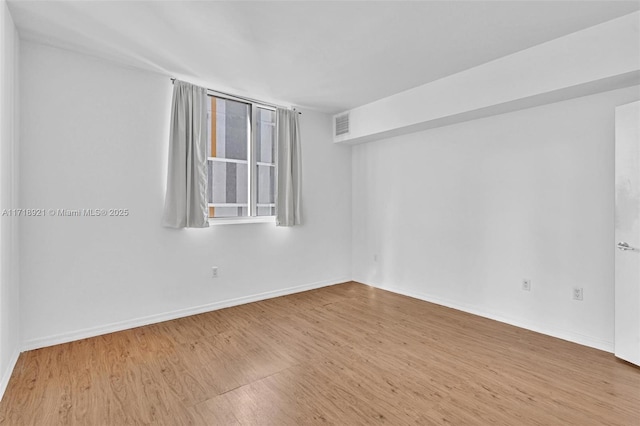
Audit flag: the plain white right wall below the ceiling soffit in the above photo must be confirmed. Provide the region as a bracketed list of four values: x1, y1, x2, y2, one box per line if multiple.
[352, 87, 640, 351]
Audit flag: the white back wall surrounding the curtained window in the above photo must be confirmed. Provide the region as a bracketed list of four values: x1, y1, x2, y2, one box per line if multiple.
[20, 42, 351, 348]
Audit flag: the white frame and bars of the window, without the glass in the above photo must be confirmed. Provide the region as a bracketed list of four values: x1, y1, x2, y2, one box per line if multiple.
[207, 90, 278, 225]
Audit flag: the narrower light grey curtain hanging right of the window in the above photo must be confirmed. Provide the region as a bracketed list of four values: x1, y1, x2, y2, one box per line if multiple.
[276, 108, 302, 226]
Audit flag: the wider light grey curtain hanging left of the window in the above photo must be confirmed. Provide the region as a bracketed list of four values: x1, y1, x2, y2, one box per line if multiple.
[162, 80, 209, 228]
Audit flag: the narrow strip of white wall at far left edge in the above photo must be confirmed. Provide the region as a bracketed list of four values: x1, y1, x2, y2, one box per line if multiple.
[0, 0, 20, 398]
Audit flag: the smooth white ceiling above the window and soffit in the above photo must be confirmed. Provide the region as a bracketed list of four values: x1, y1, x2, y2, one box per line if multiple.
[9, 0, 640, 112]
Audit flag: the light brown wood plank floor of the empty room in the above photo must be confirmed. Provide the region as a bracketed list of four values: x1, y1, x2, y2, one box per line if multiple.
[0, 283, 640, 426]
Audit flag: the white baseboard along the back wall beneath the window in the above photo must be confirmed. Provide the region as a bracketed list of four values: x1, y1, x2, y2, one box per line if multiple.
[21, 277, 351, 352]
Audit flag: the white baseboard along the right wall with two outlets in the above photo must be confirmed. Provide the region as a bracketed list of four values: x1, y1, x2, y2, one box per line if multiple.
[362, 279, 614, 353]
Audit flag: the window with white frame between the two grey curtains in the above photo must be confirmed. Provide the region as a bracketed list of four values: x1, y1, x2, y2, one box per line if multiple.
[207, 96, 276, 218]
